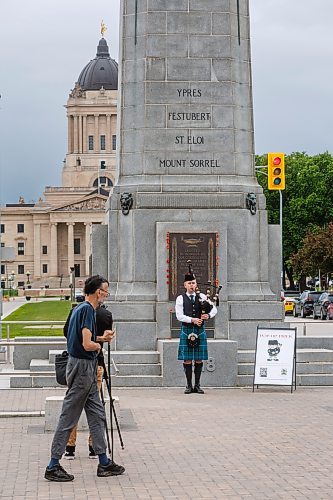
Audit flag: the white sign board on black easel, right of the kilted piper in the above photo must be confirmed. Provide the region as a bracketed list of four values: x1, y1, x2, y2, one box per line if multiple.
[253, 327, 296, 391]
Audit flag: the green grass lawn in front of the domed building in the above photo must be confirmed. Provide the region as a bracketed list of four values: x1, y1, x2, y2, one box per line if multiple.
[2, 300, 72, 339]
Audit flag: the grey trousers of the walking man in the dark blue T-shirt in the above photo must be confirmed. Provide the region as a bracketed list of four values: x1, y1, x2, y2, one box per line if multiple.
[51, 356, 106, 460]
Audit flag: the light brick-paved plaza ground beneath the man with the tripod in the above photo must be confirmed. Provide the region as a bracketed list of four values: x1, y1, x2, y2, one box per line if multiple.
[0, 387, 333, 500]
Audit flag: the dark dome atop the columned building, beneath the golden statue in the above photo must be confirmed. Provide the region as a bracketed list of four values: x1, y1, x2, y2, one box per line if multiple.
[77, 38, 118, 90]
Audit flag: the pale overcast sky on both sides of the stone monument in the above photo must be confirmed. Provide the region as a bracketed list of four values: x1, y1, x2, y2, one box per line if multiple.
[0, 0, 333, 204]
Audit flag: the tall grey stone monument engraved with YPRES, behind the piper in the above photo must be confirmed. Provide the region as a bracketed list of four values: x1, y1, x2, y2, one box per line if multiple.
[92, 0, 283, 387]
